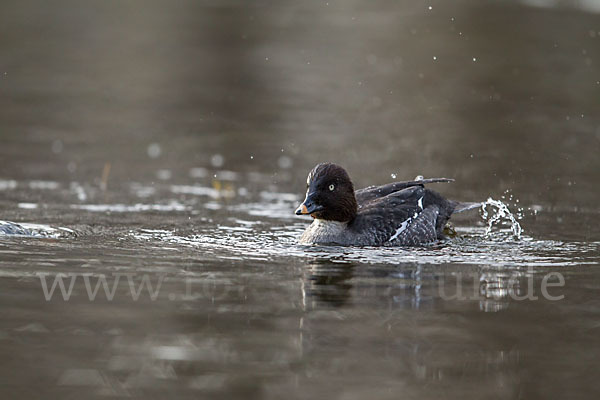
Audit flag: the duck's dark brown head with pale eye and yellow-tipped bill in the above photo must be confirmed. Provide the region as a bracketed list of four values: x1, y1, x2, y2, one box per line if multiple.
[296, 163, 357, 222]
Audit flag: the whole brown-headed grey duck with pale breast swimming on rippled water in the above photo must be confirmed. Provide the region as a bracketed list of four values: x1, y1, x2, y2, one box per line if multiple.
[296, 163, 480, 246]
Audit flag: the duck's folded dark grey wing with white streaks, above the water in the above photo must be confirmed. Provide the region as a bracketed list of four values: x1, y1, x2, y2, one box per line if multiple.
[348, 184, 456, 246]
